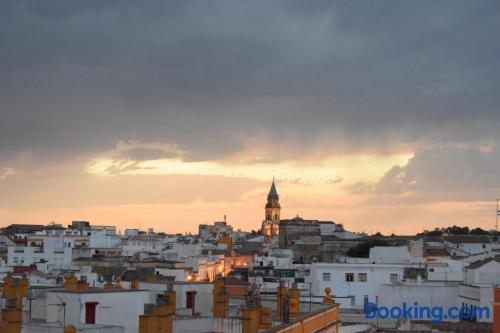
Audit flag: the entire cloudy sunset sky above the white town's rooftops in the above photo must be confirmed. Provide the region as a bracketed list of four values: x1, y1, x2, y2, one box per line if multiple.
[0, 0, 500, 234]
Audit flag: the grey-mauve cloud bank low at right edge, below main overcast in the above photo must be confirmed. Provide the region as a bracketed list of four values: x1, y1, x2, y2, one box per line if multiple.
[347, 145, 500, 203]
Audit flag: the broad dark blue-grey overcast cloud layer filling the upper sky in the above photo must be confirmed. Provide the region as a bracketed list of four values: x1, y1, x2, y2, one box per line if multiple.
[0, 1, 500, 163]
